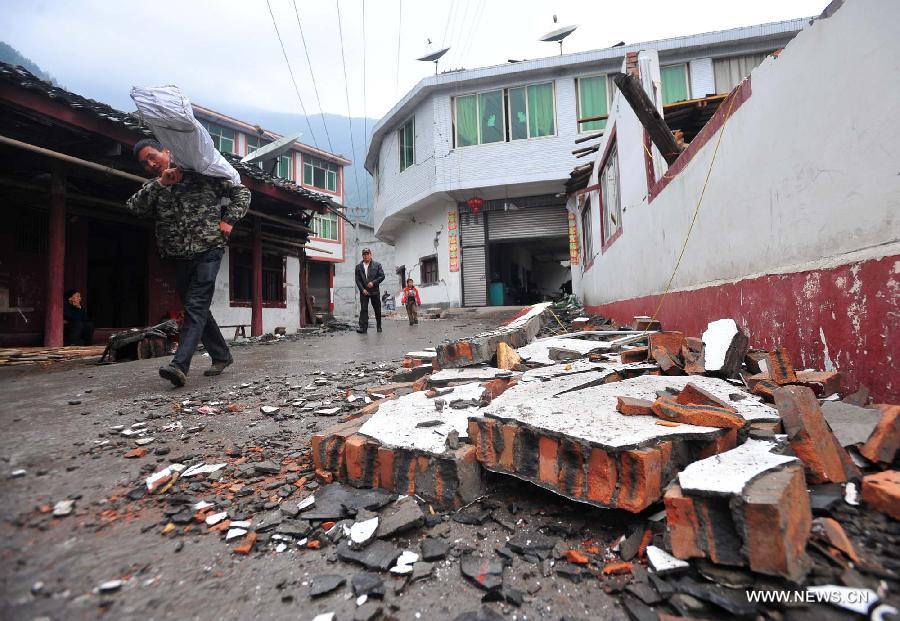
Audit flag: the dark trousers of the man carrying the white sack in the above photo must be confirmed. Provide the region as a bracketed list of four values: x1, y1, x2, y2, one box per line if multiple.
[172, 248, 231, 373]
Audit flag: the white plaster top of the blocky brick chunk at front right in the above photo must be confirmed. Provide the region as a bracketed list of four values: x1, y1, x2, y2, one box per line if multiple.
[678, 440, 800, 496]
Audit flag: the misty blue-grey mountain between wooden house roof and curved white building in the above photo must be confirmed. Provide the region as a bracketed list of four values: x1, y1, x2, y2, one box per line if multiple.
[229, 104, 377, 224]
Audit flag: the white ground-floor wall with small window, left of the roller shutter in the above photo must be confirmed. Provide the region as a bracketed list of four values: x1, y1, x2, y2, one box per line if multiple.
[387, 201, 462, 307]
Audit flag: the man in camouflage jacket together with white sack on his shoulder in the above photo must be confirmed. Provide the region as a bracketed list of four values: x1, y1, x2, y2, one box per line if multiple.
[126, 87, 250, 386]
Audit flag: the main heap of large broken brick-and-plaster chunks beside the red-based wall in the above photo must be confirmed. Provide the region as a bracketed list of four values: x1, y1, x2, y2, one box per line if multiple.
[313, 305, 900, 619]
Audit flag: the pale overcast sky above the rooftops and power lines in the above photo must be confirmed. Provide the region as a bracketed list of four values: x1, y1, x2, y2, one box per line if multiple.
[0, 0, 828, 118]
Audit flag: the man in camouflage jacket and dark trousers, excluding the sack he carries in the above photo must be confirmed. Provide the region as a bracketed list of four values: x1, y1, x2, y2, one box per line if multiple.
[126, 140, 250, 386]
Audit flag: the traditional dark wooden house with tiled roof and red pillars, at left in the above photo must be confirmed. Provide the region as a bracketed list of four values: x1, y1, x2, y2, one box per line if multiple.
[0, 63, 342, 346]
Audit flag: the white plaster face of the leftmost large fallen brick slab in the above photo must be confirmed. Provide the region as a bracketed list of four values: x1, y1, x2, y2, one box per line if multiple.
[359, 383, 484, 455]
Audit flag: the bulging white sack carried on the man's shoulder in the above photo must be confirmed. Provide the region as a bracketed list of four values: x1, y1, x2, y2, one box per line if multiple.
[131, 86, 241, 183]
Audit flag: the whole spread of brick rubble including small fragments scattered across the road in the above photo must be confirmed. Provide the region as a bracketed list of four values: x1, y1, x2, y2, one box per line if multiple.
[11, 304, 900, 620]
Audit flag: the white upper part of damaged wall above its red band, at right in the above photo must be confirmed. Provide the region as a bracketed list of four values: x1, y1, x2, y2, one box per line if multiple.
[573, 0, 900, 305]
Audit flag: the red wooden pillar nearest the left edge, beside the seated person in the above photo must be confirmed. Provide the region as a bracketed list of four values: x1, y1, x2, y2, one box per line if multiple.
[44, 166, 66, 347]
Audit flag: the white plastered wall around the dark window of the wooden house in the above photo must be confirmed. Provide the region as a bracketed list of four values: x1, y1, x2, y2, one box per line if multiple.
[210, 249, 300, 334]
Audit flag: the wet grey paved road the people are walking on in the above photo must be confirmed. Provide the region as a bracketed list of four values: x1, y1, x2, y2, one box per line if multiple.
[0, 311, 623, 620]
